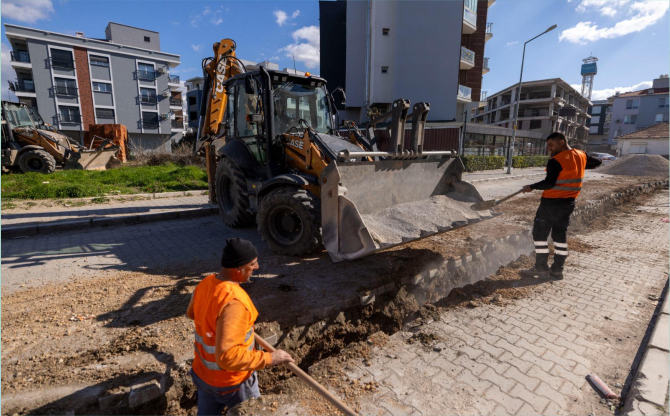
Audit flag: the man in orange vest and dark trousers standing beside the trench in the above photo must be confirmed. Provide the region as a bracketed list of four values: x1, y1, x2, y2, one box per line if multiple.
[520, 132, 602, 280]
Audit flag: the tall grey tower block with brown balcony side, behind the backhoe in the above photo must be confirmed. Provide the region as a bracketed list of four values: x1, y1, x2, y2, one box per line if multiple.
[319, 0, 494, 122]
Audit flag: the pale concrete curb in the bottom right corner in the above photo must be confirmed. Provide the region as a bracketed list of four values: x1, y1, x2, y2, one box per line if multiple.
[622, 280, 670, 416]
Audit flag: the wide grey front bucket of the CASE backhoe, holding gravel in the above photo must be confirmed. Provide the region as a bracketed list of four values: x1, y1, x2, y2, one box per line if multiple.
[321, 158, 492, 261]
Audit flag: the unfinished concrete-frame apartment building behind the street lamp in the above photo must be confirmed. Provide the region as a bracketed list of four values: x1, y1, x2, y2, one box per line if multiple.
[473, 78, 592, 144]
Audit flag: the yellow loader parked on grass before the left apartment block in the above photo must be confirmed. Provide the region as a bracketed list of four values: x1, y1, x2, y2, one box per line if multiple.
[2, 101, 119, 173]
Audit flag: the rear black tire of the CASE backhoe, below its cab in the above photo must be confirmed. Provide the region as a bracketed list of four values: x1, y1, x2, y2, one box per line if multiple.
[216, 158, 254, 227]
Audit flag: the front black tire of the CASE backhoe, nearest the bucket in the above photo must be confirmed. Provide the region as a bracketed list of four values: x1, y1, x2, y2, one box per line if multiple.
[258, 187, 321, 256]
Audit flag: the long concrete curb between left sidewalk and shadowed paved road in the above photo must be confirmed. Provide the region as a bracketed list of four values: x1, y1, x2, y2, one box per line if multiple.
[2, 205, 219, 239]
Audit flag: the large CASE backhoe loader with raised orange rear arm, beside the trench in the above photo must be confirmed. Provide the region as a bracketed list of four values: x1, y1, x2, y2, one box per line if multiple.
[196, 39, 492, 261]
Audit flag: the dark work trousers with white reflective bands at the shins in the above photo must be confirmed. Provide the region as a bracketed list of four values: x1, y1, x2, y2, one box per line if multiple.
[533, 198, 575, 272]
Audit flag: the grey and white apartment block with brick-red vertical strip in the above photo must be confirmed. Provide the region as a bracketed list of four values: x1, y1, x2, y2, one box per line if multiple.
[3, 22, 184, 151]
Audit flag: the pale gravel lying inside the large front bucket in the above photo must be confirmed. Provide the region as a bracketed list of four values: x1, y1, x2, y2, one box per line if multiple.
[361, 192, 491, 248]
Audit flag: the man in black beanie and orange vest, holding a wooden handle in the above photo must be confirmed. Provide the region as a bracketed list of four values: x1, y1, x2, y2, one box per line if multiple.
[186, 238, 293, 415]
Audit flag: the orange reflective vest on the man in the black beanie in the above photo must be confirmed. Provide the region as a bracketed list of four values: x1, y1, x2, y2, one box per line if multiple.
[193, 274, 258, 392]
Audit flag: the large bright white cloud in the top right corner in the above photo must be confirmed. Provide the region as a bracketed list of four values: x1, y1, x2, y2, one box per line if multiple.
[559, 0, 670, 45]
